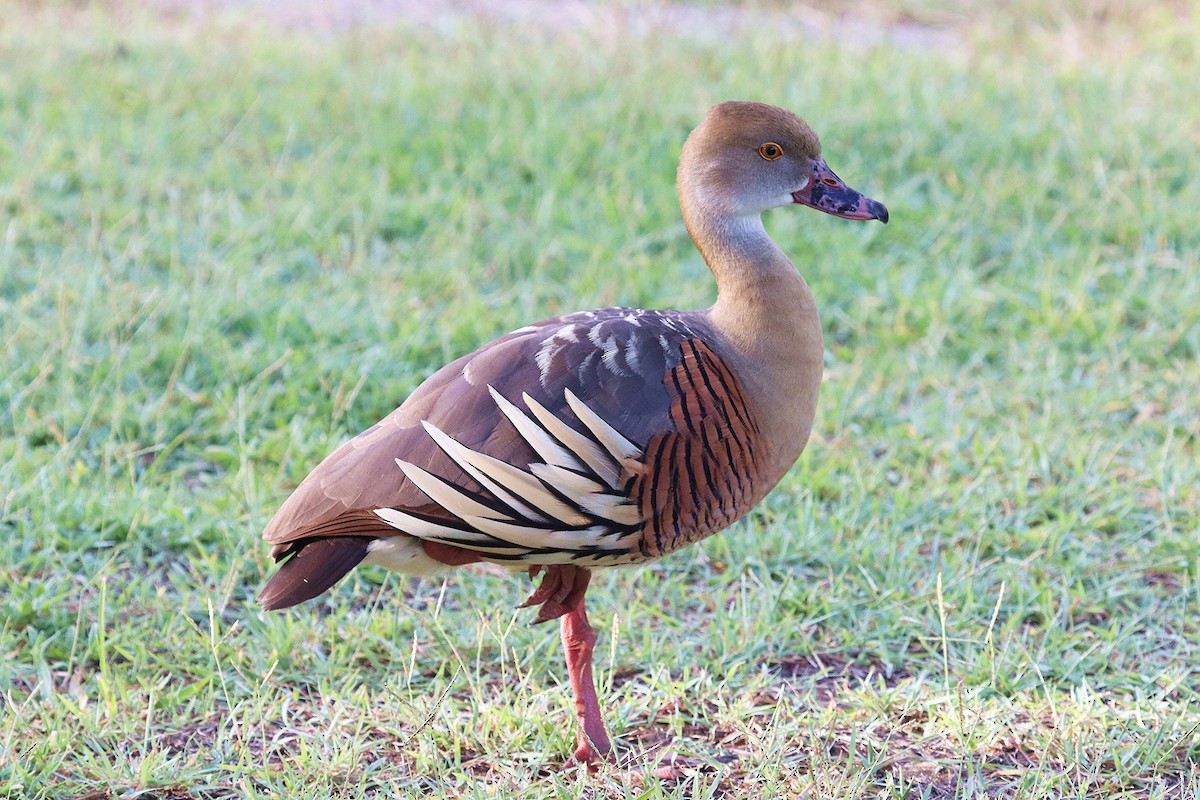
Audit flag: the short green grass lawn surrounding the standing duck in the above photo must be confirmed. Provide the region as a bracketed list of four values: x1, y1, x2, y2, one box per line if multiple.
[0, 0, 1200, 800]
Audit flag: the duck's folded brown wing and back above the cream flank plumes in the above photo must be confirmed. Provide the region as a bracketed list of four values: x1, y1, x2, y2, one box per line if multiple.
[264, 308, 707, 560]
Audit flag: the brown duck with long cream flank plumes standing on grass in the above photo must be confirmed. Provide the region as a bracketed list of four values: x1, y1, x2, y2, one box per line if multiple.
[259, 102, 887, 762]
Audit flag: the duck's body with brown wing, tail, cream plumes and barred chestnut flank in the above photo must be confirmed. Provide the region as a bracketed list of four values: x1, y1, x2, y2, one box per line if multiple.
[259, 309, 769, 608]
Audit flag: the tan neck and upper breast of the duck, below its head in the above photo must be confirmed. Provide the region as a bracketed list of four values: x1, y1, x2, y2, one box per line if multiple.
[684, 204, 824, 483]
